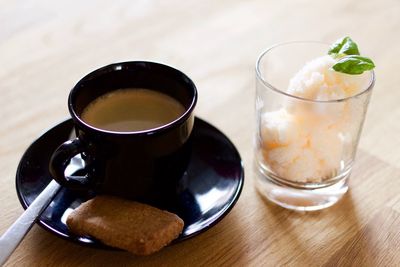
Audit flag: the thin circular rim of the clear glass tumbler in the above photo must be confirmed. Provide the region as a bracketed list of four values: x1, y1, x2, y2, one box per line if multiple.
[255, 41, 375, 103]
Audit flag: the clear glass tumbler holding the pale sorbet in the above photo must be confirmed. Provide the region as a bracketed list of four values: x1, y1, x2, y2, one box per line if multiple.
[254, 42, 375, 211]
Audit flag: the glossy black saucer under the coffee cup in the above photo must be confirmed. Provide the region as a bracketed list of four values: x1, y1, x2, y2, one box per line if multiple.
[16, 118, 244, 248]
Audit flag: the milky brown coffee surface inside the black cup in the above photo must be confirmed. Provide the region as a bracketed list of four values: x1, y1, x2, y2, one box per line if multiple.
[81, 88, 185, 132]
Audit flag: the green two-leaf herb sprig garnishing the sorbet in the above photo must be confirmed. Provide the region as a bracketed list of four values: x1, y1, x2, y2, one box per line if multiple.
[328, 36, 375, 75]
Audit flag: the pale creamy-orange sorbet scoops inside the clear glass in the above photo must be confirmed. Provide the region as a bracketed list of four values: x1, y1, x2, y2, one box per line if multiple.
[261, 55, 368, 182]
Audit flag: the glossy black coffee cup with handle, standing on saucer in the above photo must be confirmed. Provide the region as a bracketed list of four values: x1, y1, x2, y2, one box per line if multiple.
[49, 61, 197, 207]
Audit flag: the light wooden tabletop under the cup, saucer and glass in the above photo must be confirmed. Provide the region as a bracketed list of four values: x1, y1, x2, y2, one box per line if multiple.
[0, 0, 400, 266]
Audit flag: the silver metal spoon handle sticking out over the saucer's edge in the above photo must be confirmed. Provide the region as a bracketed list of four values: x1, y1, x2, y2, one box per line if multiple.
[0, 180, 61, 266]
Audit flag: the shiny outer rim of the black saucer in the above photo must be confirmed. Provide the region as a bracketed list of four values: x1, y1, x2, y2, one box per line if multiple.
[15, 116, 245, 250]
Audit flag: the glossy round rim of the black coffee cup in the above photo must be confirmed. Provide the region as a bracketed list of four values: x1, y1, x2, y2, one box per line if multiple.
[68, 60, 198, 135]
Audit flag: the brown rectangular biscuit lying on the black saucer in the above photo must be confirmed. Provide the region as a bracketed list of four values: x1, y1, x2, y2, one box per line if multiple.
[67, 196, 183, 255]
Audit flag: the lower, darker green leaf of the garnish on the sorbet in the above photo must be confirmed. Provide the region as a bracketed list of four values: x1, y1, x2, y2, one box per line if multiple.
[332, 55, 375, 75]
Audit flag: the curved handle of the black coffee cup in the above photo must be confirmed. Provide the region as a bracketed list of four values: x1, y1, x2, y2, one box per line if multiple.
[49, 138, 89, 190]
